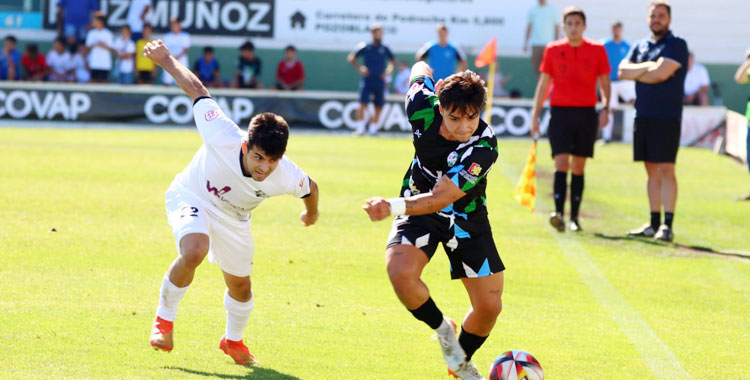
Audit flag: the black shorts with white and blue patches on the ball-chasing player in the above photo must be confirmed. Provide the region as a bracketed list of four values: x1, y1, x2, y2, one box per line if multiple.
[388, 214, 505, 280]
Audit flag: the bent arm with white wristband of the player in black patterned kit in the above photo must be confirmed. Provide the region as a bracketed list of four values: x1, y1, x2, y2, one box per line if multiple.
[362, 175, 466, 222]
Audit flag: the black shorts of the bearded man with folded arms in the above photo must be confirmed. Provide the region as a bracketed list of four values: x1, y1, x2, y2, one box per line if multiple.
[633, 117, 682, 163]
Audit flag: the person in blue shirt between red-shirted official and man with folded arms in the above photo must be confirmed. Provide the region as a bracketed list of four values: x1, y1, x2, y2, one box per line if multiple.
[602, 21, 635, 144]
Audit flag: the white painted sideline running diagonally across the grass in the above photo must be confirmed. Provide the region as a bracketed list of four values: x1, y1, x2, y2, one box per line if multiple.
[503, 165, 693, 380]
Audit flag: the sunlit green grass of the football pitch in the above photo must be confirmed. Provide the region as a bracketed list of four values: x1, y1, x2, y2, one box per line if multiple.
[0, 129, 750, 380]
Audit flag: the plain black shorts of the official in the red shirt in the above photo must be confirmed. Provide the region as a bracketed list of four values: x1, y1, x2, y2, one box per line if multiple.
[547, 107, 599, 157]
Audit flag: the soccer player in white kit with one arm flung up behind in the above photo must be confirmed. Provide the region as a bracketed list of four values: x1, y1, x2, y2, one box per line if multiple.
[143, 40, 318, 365]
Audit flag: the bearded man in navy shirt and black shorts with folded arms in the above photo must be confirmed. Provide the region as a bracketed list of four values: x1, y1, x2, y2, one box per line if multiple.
[619, 1, 688, 242]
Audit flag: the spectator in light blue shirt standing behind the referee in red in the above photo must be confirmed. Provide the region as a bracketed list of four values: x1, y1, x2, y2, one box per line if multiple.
[523, 0, 560, 78]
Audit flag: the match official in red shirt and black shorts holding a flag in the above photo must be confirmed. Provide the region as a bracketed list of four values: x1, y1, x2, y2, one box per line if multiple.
[531, 7, 610, 232]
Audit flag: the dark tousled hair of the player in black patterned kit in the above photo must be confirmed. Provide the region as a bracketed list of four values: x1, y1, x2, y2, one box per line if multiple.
[438, 70, 487, 115]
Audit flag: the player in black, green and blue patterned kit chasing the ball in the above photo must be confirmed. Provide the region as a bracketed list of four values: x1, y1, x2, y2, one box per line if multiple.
[364, 62, 505, 380]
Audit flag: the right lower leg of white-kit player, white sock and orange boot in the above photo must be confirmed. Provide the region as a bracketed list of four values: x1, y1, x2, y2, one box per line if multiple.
[219, 272, 258, 365]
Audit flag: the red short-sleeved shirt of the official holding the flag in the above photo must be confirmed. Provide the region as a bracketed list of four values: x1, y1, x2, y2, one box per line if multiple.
[540, 37, 610, 107]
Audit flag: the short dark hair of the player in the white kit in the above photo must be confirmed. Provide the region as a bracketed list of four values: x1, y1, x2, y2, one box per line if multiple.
[247, 112, 289, 158]
